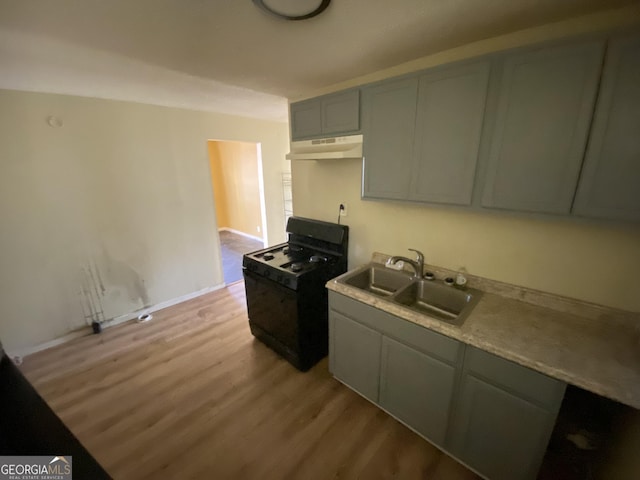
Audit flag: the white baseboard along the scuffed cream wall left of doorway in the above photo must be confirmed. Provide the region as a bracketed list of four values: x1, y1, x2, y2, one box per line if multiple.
[10, 284, 225, 359]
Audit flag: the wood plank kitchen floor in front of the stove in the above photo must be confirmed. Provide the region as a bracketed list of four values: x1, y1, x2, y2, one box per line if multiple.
[21, 282, 479, 480]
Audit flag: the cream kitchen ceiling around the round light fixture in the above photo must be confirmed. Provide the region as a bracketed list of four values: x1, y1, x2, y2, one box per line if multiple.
[0, 0, 637, 121]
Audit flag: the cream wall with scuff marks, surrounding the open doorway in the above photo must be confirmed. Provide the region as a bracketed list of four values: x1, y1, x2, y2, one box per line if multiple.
[0, 90, 288, 352]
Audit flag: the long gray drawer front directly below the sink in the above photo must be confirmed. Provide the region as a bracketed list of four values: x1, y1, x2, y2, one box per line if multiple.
[329, 291, 461, 364]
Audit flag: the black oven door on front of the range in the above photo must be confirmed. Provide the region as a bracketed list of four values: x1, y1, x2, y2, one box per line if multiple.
[243, 269, 299, 356]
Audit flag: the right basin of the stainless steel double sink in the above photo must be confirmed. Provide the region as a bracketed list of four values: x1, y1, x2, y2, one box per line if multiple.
[393, 280, 481, 324]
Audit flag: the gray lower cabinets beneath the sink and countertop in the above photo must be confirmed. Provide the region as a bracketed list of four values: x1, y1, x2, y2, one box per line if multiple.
[329, 292, 566, 480]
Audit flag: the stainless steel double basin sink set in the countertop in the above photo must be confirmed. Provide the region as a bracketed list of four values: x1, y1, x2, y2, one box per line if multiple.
[336, 264, 482, 326]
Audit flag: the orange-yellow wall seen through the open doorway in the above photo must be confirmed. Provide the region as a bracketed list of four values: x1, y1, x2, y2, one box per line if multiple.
[208, 141, 262, 238]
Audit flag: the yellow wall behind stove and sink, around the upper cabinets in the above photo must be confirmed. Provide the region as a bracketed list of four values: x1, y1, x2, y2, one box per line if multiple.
[292, 8, 640, 311]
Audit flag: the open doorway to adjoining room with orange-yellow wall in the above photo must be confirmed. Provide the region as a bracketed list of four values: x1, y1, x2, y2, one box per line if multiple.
[207, 140, 267, 285]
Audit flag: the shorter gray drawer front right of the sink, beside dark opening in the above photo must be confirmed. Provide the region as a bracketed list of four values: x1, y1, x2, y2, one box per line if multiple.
[465, 346, 566, 411]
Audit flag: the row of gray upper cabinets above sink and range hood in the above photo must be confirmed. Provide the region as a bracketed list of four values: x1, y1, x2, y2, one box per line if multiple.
[300, 33, 640, 221]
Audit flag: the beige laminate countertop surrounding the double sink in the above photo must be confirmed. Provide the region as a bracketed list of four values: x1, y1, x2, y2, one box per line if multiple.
[327, 254, 640, 409]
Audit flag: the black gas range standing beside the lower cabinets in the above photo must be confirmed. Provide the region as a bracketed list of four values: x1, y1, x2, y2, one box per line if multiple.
[242, 217, 349, 371]
